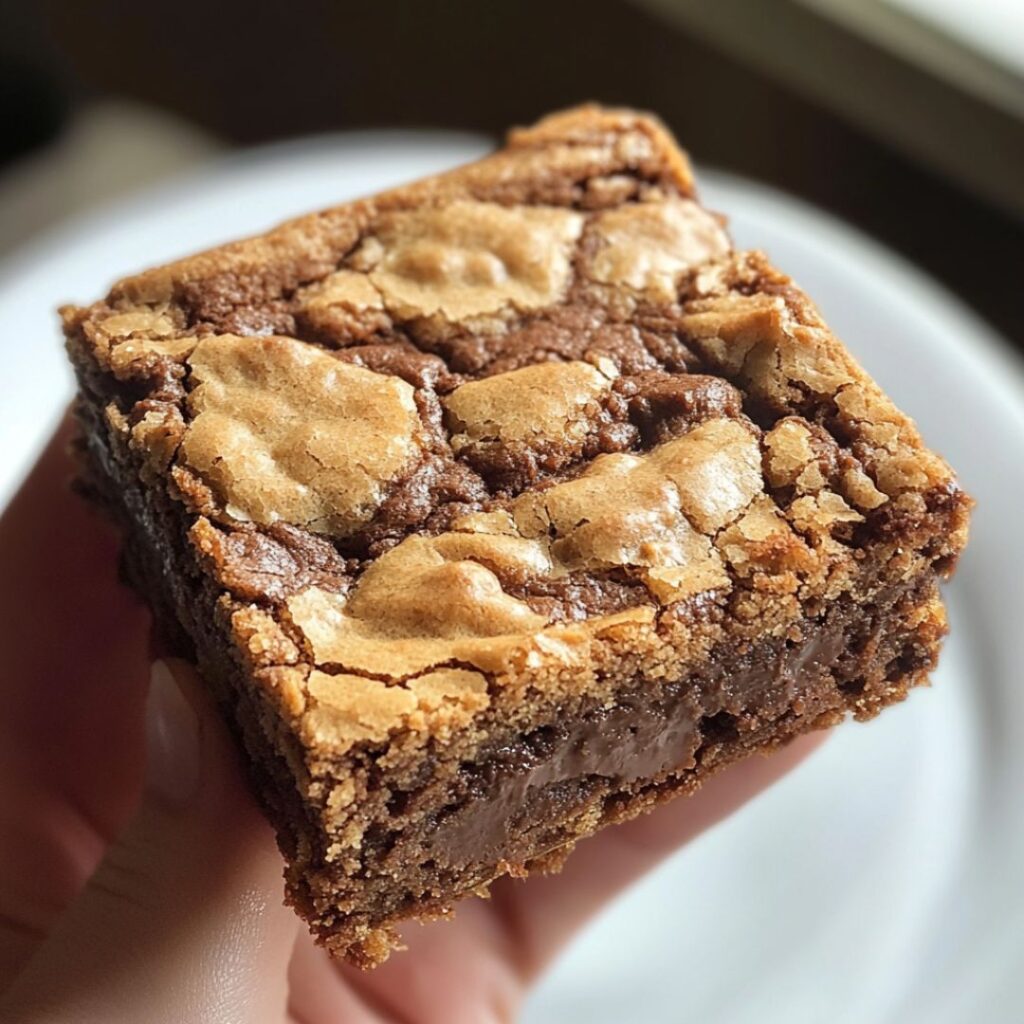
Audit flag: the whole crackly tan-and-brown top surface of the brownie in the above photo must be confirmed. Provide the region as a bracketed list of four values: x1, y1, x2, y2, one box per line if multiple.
[63, 108, 967, 752]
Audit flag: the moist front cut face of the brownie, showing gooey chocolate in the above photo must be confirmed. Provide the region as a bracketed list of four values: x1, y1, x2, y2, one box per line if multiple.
[300, 573, 943, 958]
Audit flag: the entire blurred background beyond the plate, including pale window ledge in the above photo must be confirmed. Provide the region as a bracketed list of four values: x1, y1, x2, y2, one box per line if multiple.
[0, 0, 1024, 346]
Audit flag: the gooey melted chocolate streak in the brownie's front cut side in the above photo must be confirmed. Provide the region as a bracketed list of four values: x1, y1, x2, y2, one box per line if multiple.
[419, 623, 846, 869]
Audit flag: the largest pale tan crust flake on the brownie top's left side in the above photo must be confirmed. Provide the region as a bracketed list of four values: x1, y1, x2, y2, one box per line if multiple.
[178, 335, 422, 537]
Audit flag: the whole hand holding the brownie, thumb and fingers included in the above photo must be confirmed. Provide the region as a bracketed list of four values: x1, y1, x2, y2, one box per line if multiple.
[0, 417, 817, 1024]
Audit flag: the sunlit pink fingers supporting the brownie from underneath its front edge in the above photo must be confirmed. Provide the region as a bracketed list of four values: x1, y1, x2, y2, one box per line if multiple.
[338, 735, 821, 1024]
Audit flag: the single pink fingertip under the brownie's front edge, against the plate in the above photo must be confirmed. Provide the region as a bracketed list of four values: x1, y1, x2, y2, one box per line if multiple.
[490, 733, 825, 979]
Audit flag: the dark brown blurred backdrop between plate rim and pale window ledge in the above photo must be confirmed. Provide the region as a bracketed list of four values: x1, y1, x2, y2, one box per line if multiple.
[0, 0, 1024, 350]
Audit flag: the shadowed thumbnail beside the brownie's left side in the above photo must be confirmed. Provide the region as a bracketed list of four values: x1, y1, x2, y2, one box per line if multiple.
[145, 662, 200, 806]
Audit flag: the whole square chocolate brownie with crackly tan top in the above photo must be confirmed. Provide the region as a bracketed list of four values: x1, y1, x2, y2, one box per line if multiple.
[63, 108, 970, 967]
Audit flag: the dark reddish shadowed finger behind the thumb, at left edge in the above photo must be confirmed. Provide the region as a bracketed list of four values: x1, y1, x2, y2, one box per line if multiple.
[0, 413, 148, 991]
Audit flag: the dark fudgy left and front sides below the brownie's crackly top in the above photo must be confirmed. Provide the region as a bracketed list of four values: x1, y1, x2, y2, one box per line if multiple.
[79, 402, 945, 967]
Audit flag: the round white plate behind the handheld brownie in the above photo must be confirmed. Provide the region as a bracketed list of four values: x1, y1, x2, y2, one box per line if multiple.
[0, 133, 1024, 1024]
